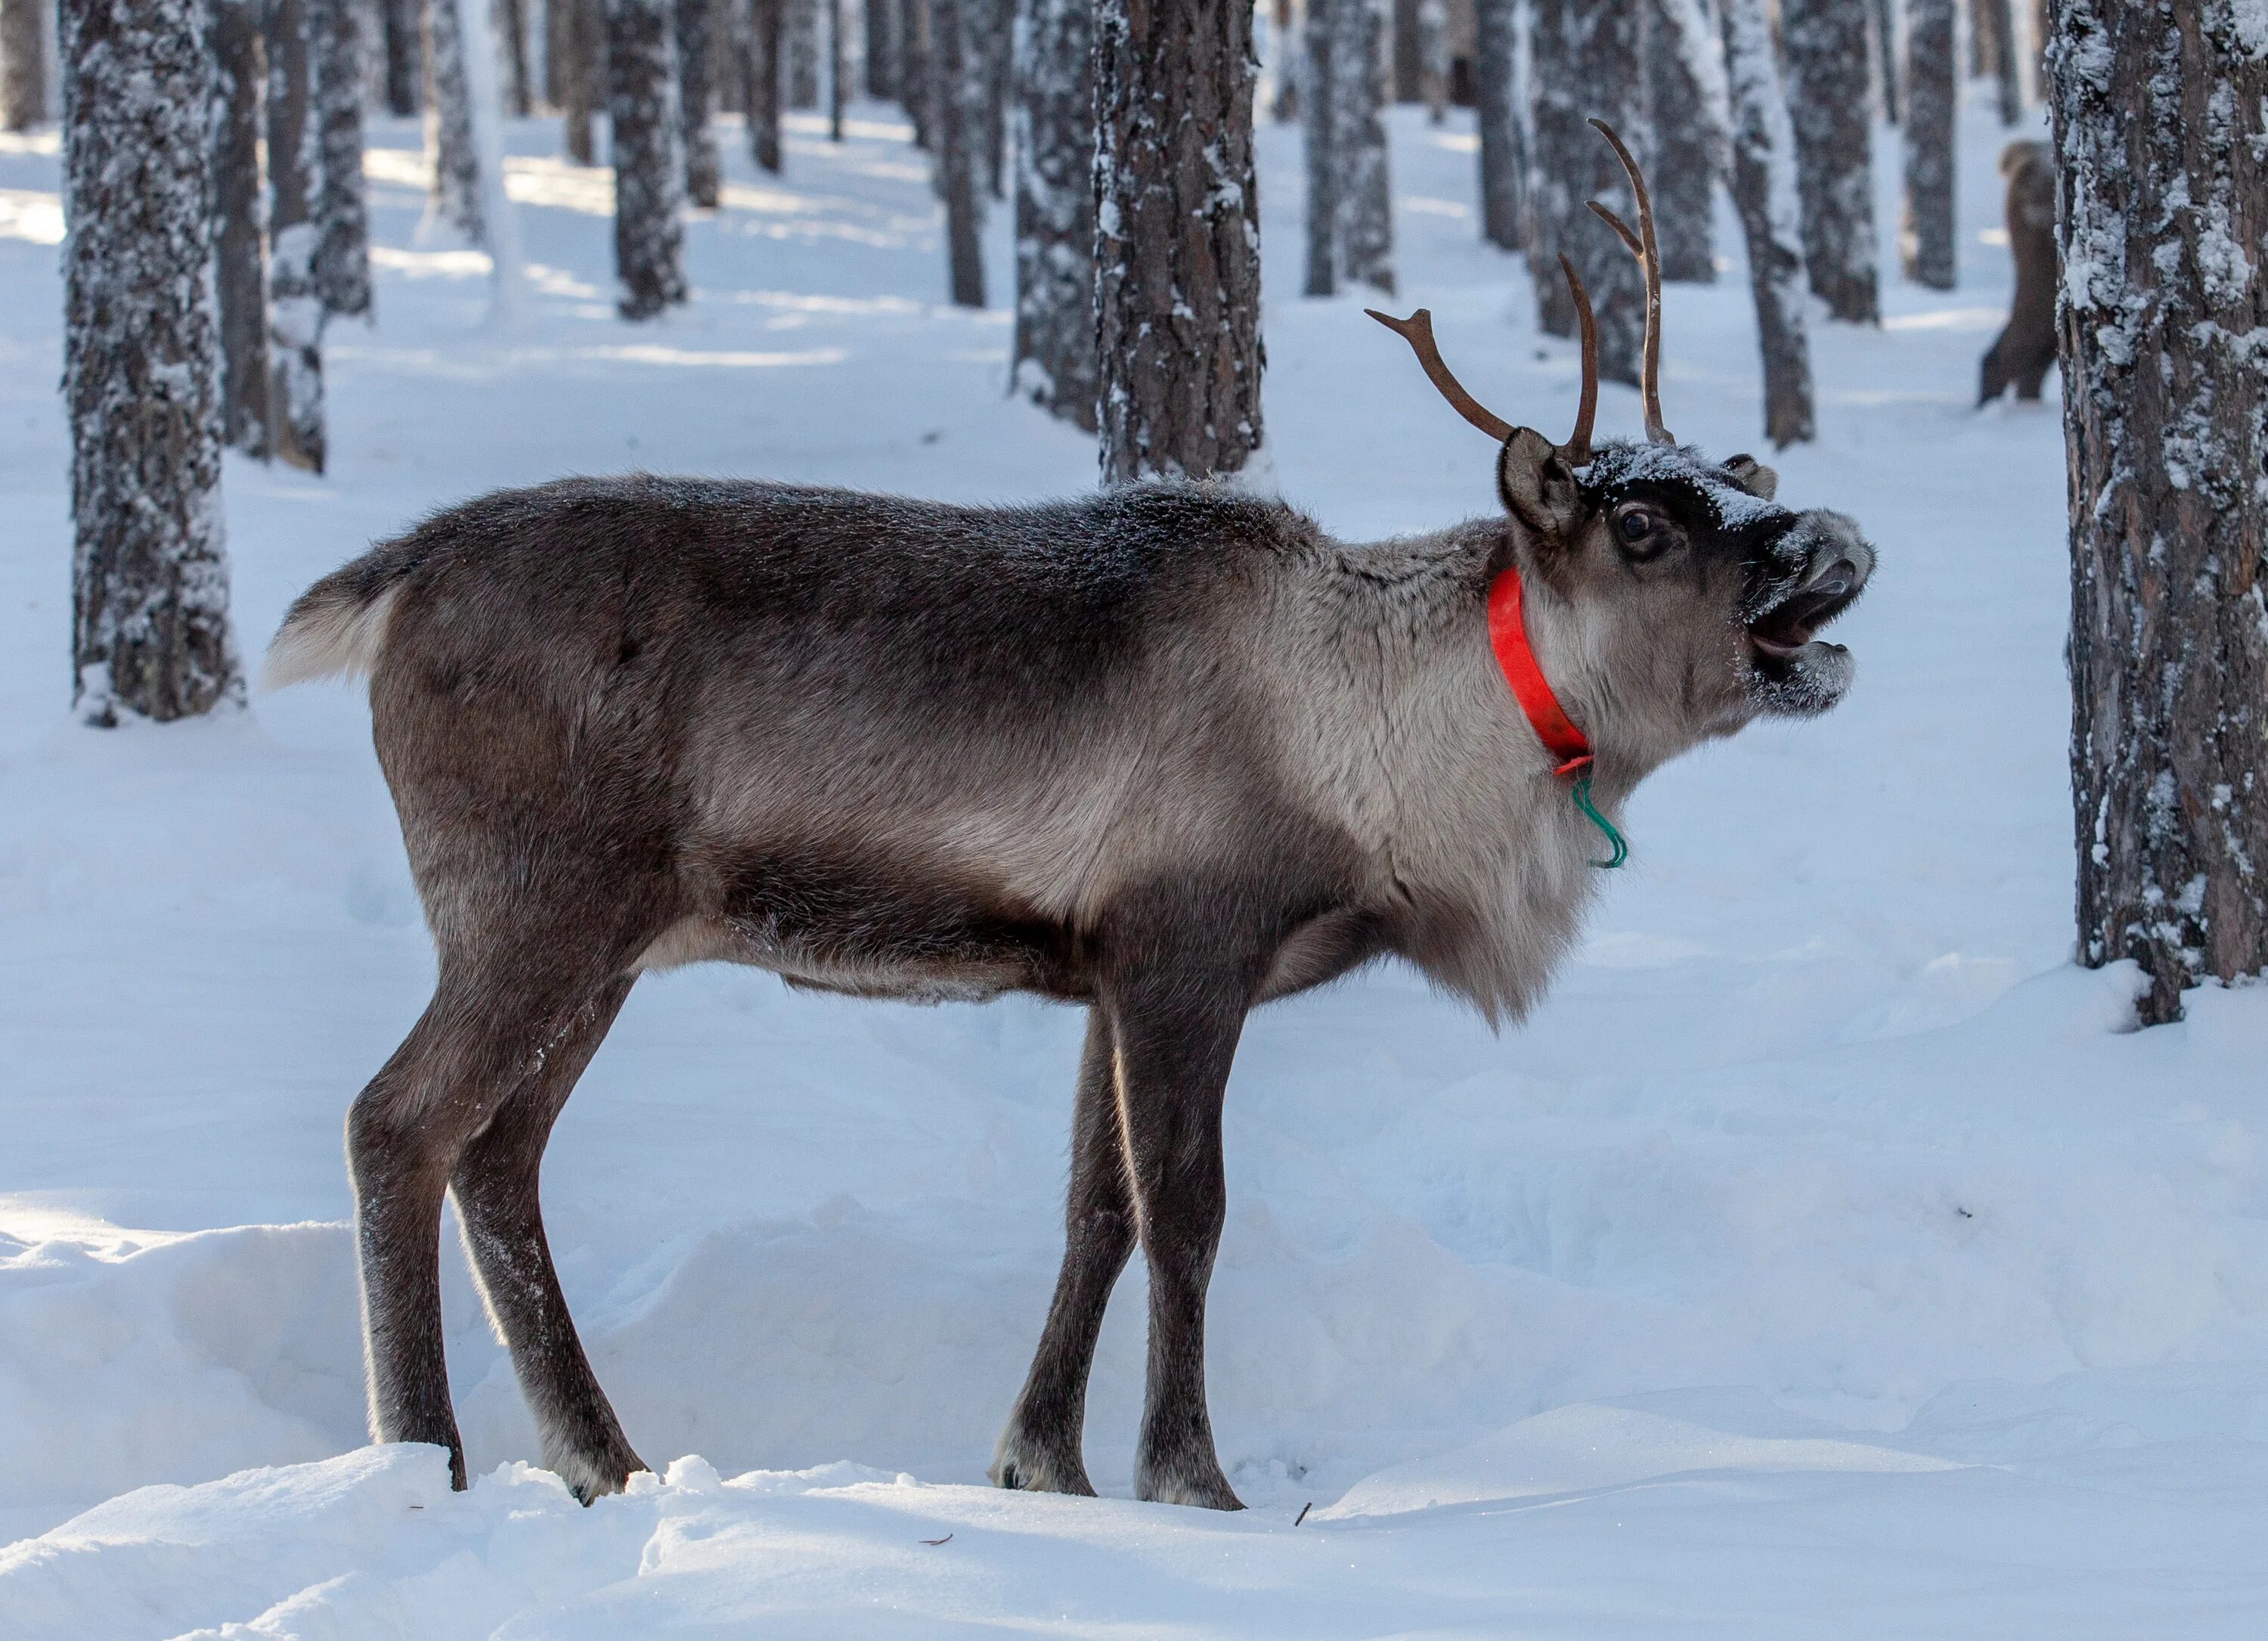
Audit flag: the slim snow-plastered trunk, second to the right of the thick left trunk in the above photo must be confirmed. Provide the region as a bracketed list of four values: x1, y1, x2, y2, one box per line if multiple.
[265, 0, 327, 472]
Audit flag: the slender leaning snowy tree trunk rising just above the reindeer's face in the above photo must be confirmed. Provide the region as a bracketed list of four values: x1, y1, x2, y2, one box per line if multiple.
[1719, 0, 1812, 447]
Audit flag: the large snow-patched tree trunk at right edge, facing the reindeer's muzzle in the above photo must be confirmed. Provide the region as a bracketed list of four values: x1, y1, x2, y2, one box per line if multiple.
[2048, 0, 2268, 1024]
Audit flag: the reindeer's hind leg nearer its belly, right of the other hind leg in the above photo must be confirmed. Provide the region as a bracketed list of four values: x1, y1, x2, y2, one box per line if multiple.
[449, 976, 646, 1505]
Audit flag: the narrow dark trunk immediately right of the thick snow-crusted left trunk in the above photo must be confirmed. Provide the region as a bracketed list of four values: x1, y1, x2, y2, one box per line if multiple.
[204, 0, 268, 461]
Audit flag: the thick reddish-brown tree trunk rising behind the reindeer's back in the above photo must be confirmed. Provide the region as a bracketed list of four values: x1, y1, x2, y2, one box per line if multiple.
[1095, 0, 1263, 483]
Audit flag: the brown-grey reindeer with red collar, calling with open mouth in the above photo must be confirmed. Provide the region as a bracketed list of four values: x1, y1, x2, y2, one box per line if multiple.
[265, 127, 1873, 1509]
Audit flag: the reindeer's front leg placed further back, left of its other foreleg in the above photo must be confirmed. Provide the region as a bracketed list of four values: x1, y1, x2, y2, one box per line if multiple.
[991, 1006, 1134, 1494]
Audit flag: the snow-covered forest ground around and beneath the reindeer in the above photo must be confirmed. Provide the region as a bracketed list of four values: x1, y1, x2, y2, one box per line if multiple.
[0, 109, 2268, 1641]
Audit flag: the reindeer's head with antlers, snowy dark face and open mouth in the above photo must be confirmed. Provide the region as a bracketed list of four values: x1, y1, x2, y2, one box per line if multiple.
[1372, 120, 1873, 760]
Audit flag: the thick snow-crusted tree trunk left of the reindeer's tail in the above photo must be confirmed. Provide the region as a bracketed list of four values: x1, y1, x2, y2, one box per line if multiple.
[61, 0, 243, 726]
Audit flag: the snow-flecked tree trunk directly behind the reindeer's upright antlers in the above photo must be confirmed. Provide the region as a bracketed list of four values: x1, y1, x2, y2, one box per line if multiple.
[1529, 0, 1651, 383]
